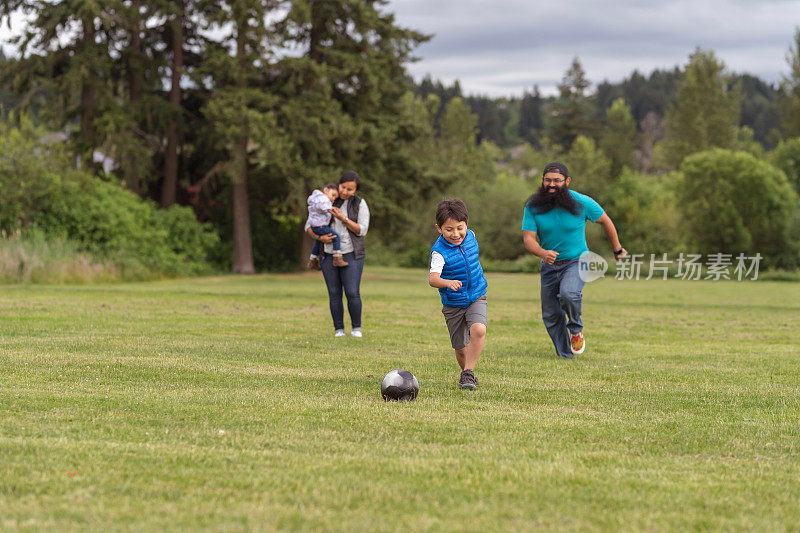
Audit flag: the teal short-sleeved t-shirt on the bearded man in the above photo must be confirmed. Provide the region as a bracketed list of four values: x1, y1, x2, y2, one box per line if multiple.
[522, 191, 603, 261]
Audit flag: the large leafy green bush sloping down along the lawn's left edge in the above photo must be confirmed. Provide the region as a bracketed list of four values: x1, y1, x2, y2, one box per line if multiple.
[0, 117, 219, 277]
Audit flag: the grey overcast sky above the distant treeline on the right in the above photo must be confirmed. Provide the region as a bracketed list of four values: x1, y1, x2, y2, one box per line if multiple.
[386, 0, 800, 96]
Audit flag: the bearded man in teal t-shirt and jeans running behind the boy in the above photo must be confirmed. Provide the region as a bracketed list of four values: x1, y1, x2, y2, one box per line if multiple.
[522, 161, 628, 357]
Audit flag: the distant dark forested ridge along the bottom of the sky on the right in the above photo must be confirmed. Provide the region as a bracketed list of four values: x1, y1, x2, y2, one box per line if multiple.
[416, 35, 798, 158]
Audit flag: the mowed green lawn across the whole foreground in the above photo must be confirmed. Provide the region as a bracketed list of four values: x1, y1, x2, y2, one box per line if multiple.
[0, 265, 800, 531]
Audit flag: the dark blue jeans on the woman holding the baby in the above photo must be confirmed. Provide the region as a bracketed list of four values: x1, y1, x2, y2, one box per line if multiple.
[319, 252, 364, 329]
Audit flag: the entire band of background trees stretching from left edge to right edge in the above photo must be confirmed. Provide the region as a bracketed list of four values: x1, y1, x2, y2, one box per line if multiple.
[0, 0, 800, 273]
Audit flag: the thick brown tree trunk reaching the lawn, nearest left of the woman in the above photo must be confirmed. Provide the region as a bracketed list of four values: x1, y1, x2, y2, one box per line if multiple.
[233, 20, 256, 274]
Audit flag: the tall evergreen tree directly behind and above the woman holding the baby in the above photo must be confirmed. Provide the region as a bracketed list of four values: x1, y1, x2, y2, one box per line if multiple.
[278, 0, 427, 261]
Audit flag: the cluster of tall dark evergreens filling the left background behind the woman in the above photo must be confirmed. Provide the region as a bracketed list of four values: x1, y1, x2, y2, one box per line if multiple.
[0, 0, 440, 273]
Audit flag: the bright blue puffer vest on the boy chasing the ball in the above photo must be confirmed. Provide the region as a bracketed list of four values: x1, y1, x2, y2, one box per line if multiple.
[431, 229, 487, 307]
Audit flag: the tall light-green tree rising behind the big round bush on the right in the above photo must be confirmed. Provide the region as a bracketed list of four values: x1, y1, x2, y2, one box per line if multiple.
[660, 50, 740, 168]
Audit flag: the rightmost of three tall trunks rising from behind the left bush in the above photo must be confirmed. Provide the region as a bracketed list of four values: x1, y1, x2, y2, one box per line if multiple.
[161, 1, 184, 207]
